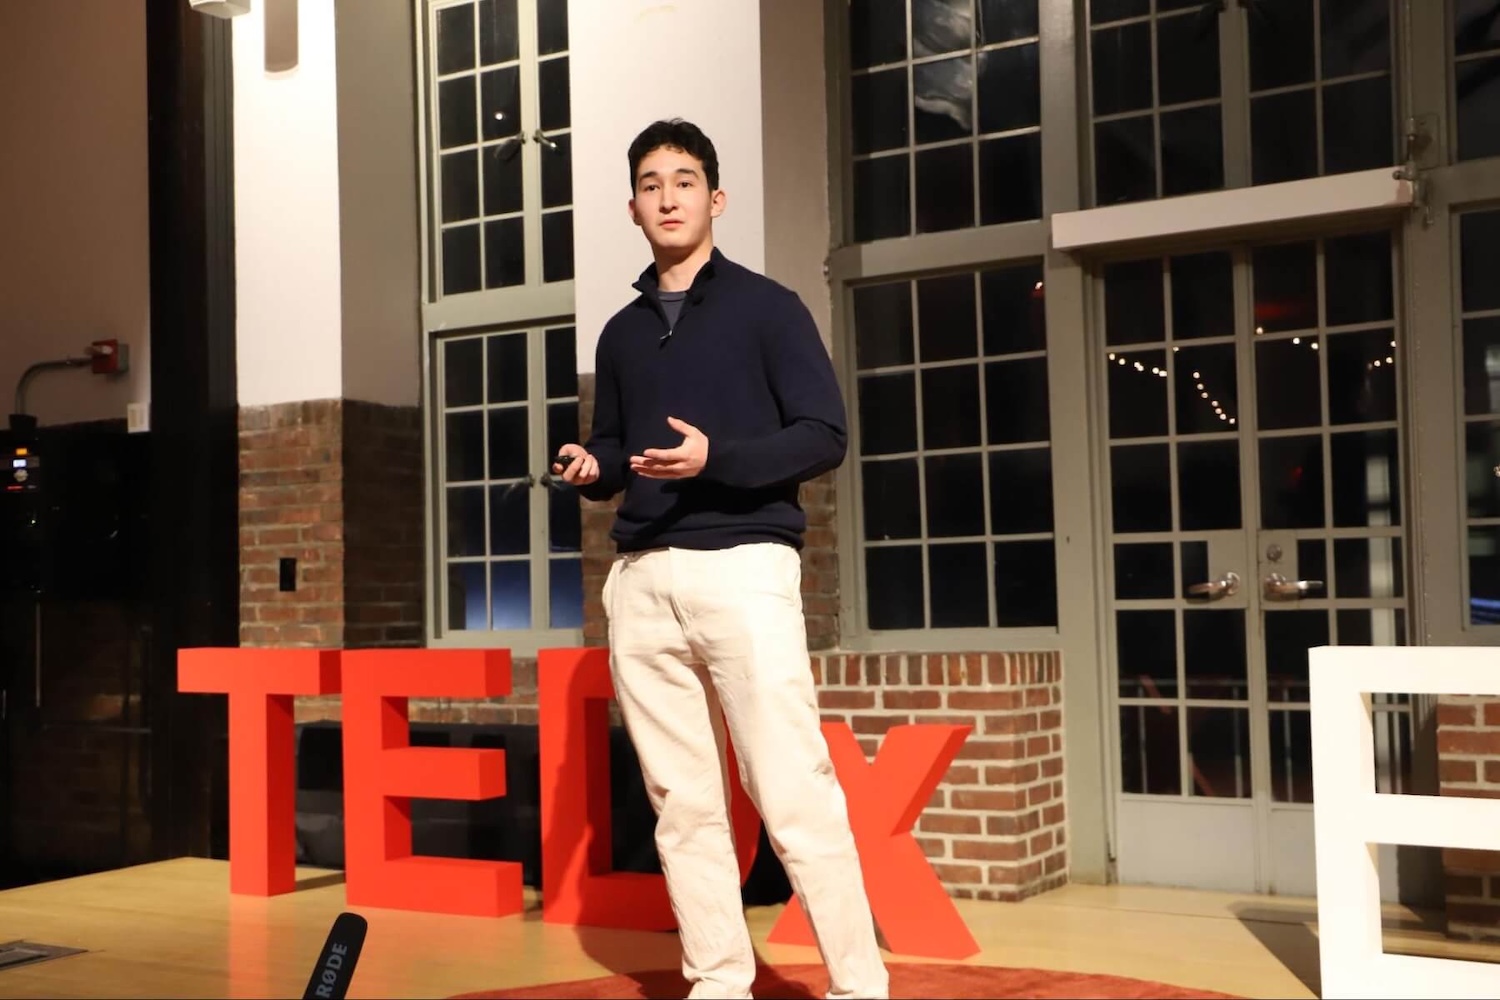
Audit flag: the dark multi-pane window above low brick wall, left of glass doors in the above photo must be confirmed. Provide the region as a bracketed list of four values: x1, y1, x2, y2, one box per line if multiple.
[854, 262, 1058, 630]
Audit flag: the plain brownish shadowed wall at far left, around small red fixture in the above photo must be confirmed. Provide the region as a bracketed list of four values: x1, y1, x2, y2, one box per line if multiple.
[0, 0, 150, 424]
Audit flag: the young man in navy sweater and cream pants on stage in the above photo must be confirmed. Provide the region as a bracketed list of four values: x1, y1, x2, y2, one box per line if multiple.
[554, 120, 890, 997]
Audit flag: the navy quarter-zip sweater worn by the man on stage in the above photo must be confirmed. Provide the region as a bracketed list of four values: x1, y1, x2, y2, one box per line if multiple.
[579, 249, 849, 552]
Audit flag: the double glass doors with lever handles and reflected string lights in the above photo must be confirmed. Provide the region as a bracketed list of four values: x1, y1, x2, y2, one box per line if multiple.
[1101, 231, 1410, 895]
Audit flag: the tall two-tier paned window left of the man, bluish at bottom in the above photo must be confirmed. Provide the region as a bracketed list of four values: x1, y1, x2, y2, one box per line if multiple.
[420, 0, 584, 648]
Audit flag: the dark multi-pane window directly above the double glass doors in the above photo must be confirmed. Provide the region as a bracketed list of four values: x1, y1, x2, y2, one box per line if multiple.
[1089, 0, 1397, 205]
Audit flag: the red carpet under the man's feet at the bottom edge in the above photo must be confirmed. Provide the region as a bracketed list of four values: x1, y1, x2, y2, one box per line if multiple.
[453, 963, 1229, 1000]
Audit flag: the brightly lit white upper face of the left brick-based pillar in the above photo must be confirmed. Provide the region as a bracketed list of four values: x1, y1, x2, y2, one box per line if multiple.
[233, 0, 344, 406]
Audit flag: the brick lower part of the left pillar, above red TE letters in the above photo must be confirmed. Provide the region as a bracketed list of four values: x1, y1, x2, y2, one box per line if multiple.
[240, 399, 425, 648]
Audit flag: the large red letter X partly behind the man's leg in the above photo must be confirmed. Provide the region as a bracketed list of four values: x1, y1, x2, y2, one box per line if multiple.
[768, 723, 980, 958]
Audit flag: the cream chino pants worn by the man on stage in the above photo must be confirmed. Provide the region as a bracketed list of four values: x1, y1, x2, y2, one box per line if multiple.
[603, 543, 890, 997]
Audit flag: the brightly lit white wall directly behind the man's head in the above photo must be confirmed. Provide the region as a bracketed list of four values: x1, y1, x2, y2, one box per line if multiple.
[567, 0, 768, 372]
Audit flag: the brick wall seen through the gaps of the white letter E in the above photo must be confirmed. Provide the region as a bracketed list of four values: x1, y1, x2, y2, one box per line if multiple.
[1437, 697, 1500, 940]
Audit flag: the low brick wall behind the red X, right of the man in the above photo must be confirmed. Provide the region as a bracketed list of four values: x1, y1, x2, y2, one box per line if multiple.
[813, 652, 1068, 901]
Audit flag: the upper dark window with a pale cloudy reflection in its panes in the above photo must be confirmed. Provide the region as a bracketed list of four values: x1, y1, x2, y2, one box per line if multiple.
[849, 0, 1041, 243]
